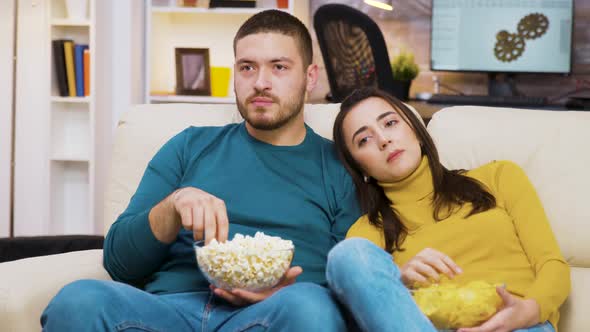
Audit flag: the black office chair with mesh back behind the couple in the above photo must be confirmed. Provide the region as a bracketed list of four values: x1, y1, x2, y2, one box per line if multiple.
[313, 4, 400, 102]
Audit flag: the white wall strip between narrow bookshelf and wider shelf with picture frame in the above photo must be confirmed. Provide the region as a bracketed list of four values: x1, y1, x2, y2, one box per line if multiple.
[94, 0, 144, 234]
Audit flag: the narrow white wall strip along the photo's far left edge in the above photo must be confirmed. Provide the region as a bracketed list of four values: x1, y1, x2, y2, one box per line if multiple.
[0, 0, 15, 237]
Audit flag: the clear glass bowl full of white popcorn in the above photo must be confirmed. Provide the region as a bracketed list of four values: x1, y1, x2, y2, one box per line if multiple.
[194, 232, 295, 292]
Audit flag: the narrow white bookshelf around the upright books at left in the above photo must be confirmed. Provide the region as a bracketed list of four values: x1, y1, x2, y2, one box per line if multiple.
[47, 0, 97, 234]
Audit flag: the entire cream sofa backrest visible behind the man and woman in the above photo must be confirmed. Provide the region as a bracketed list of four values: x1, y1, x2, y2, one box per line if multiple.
[104, 104, 590, 331]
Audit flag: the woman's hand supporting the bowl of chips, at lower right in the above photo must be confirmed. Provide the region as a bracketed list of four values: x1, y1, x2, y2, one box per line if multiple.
[457, 287, 539, 332]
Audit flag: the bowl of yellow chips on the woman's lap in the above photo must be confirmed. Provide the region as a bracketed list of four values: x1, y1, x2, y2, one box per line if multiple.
[411, 280, 505, 331]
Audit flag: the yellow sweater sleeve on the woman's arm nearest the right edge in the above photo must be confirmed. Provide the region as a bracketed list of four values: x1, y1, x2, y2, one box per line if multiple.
[497, 162, 571, 322]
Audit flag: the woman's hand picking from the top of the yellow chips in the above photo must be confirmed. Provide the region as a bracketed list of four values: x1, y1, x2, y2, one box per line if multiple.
[401, 248, 463, 288]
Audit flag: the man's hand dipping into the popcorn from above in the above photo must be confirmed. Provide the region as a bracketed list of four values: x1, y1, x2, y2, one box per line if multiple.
[170, 187, 229, 244]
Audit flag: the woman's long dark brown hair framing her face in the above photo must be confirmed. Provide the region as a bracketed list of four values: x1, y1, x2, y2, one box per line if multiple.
[333, 88, 496, 253]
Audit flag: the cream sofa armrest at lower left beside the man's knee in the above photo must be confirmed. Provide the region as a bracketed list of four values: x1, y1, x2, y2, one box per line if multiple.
[0, 250, 111, 331]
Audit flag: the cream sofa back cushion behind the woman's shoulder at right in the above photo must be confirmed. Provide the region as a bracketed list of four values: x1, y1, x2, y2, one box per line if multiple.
[428, 106, 590, 267]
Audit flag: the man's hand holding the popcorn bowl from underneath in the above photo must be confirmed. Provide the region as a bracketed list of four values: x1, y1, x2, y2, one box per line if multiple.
[210, 266, 303, 306]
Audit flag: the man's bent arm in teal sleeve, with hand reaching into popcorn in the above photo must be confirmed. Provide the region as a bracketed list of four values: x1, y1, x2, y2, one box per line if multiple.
[104, 129, 229, 283]
